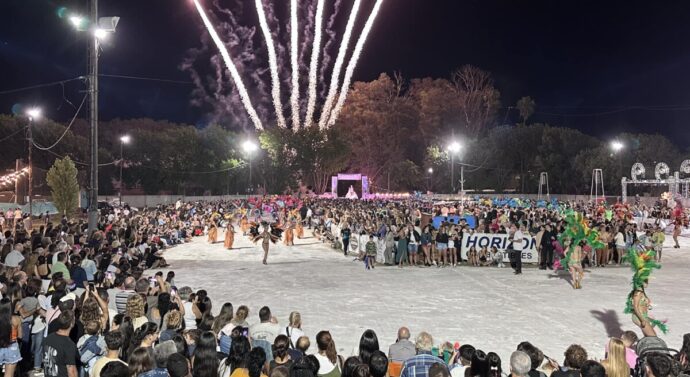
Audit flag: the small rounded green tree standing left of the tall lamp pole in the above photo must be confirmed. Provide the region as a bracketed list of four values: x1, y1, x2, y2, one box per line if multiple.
[46, 156, 79, 217]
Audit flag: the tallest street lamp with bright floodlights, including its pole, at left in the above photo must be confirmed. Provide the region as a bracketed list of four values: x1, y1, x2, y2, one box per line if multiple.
[69, 0, 120, 234]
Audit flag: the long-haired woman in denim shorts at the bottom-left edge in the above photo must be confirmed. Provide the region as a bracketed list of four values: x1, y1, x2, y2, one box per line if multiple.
[0, 297, 22, 377]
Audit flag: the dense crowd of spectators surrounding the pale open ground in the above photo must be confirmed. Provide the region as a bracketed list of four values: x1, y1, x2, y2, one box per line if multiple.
[0, 199, 690, 377]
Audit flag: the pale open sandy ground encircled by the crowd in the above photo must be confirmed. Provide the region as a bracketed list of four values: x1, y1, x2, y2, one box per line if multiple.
[157, 228, 690, 362]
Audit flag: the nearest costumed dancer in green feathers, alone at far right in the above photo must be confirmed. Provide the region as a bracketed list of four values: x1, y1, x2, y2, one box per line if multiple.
[624, 247, 668, 336]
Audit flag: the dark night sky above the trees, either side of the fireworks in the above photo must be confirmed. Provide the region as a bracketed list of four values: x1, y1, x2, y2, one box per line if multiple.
[0, 0, 690, 149]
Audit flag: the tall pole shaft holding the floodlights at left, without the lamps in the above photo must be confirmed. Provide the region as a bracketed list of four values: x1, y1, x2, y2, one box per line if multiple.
[88, 0, 98, 234]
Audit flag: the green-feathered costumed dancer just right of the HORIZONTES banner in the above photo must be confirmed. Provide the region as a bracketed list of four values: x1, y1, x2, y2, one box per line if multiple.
[559, 210, 604, 289]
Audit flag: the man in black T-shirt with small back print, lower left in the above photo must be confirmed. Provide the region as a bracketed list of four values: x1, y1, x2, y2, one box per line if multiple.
[43, 310, 79, 377]
